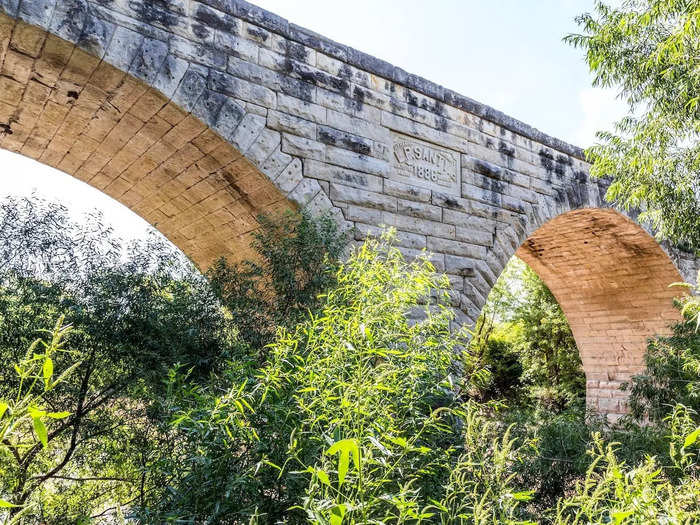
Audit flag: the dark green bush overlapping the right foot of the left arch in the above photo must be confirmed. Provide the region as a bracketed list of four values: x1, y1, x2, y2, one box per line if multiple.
[207, 210, 347, 348]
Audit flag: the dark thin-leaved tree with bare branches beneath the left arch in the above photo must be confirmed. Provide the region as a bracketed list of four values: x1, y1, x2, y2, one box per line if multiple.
[0, 199, 242, 523]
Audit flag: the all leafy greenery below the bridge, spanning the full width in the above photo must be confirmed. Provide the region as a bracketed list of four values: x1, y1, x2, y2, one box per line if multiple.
[0, 194, 700, 525]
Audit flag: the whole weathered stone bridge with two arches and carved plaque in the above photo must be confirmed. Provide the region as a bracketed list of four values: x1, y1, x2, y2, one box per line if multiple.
[0, 0, 698, 416]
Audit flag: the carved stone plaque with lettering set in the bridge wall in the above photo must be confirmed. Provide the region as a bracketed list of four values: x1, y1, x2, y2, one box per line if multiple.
[391, 132, 461, 194]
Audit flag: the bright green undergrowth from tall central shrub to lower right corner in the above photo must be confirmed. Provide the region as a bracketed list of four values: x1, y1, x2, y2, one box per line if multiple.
[140, 240, 700, 525]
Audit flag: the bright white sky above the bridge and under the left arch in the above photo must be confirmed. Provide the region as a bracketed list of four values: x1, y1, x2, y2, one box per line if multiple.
[0, 0, 624, 237]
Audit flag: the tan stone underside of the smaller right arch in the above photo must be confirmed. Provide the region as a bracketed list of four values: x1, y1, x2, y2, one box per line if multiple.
[516, 209, 682, 418]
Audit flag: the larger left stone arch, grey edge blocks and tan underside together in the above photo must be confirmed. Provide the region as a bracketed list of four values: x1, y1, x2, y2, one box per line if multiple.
[0, 2, 340, 268]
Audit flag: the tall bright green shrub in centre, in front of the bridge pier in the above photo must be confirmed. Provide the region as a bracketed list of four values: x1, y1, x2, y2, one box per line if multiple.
[143, 235, 528, 523]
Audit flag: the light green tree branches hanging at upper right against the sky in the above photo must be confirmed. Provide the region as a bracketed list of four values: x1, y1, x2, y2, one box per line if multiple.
[565, 0, 700, 250]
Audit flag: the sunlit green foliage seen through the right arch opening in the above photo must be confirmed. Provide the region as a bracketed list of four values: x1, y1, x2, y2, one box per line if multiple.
[472, 258, 585, 411]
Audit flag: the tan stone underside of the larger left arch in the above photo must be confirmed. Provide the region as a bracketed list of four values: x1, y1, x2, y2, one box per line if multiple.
[0, 15, 292, 267]
